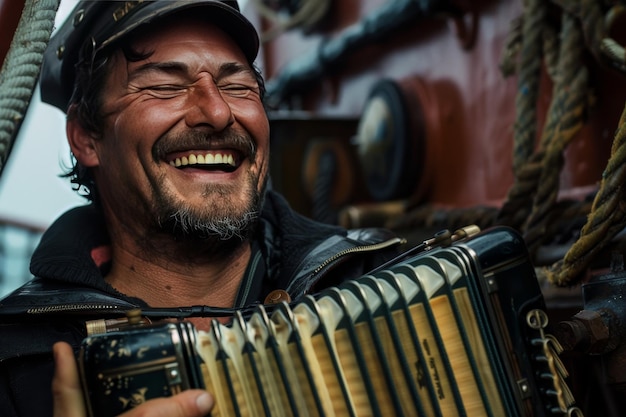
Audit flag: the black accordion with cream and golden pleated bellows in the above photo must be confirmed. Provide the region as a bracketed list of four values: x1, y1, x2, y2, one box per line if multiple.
[79, 227, 582, 417]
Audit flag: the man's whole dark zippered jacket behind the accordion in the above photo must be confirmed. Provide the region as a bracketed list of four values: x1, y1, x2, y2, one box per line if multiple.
[0, 191, 401, 417]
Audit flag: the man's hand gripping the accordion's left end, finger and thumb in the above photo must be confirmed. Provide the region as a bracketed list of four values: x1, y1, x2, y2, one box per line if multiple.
[52, 342, 213, 417]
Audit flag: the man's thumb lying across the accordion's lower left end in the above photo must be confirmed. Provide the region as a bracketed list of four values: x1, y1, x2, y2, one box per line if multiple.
[118, 390, 213, 417]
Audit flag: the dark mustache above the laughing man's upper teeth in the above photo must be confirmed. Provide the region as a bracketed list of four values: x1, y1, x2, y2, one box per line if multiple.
[152, 129, 257, 162]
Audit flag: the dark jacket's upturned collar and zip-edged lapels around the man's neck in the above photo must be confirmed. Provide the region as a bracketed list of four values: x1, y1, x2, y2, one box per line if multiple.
[0, 191, 400, 314]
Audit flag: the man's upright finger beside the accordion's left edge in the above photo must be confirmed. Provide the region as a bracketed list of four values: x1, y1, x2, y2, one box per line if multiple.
[52, 342, 86, 417]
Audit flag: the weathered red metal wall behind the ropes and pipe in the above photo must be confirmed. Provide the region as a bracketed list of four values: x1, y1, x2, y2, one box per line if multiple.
[264, 0, 626, 206]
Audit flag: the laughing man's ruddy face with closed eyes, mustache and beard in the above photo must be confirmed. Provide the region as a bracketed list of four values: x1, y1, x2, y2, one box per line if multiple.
[83, 19, 269, 244]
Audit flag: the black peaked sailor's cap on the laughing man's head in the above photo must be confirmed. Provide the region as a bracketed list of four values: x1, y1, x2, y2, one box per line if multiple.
[41, 0, 259, 111]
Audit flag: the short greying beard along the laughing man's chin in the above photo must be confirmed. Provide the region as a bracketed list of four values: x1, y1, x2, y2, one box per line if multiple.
[167, 209, 259, 241]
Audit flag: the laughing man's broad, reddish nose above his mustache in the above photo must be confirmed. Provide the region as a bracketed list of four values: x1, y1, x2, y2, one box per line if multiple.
[185, 76, 234, 131]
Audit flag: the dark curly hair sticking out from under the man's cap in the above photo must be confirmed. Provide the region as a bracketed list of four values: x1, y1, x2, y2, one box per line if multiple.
[62, 22, 265, 203]
